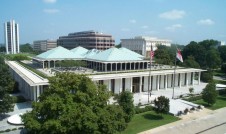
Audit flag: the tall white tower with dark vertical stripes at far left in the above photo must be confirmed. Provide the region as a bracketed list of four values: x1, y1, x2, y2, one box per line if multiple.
[5, 20, 20, 54]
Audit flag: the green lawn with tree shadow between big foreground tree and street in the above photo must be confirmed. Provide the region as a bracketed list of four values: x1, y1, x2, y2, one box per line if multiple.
[122, 111, 179, 134]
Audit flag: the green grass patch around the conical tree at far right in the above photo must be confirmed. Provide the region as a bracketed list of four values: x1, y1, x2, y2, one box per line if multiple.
[193, 95, 226, 110]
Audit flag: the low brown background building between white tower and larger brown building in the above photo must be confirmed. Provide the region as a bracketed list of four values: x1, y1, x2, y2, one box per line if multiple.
[32, 40, 57, 52]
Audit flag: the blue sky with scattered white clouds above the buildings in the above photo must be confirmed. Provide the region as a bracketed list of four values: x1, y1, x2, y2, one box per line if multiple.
[0, 0, 226, 45]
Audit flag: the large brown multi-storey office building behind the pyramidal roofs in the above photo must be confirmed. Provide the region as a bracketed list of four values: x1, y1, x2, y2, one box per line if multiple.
[57, 30, 115, 50]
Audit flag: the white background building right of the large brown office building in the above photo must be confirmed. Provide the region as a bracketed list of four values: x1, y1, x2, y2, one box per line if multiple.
[121, 36, 171, 57]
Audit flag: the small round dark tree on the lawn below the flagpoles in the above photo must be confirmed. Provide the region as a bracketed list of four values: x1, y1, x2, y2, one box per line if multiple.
[154, 96, 170, 114]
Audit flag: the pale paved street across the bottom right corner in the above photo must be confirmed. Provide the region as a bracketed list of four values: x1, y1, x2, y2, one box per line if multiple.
[140, 108, 226, 134]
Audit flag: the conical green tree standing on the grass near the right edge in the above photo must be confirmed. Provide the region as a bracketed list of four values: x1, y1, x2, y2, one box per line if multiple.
[202, 82, 217, 105]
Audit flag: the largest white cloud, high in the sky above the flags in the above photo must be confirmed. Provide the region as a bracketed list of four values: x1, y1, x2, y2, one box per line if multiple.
[159, 9, 186, 20]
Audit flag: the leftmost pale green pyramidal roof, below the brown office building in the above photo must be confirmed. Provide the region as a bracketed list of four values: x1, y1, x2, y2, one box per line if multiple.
[37, 46, 82, 59]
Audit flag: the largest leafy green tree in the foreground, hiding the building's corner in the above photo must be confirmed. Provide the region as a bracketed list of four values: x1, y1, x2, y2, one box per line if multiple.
[22, 73, 127, 134]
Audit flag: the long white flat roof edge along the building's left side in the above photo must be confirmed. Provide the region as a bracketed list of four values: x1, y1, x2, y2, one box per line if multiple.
[6, 61, 49, 86]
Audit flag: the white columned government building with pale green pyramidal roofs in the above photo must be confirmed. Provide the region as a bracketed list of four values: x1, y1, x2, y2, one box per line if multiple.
[7, 47, 204, 101]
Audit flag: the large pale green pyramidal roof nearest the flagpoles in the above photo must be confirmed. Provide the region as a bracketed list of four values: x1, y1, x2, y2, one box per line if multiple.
[90, 48, 142, 61]
